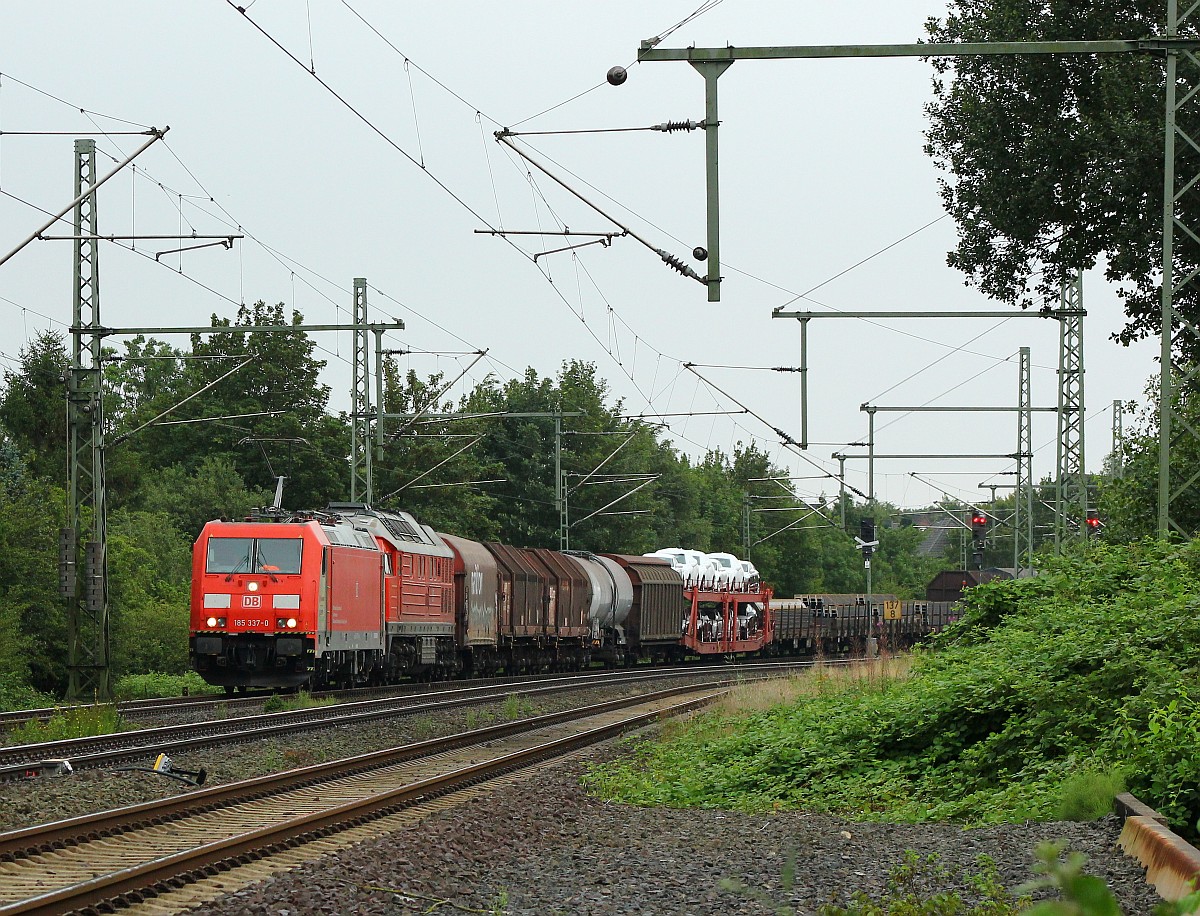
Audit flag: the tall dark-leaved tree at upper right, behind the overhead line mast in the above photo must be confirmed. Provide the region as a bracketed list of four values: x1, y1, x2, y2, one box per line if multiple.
[926, 0, 1185, 352]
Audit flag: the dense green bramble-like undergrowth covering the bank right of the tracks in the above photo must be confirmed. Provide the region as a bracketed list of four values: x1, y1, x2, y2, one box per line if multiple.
[590, 543, 1200, 836]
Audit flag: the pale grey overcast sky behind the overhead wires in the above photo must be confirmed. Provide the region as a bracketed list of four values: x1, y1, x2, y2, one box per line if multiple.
[0, 0, 1154, 505]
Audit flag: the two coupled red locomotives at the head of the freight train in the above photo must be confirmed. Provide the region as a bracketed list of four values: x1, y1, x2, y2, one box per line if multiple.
[191, 503, 458, 692]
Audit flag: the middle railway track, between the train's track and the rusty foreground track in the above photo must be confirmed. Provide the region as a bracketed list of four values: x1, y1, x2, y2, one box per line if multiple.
[0, 663, 803, 782]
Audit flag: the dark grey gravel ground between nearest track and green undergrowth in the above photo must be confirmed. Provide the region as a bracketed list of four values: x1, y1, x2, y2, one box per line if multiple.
[180, 749, 1158, 916]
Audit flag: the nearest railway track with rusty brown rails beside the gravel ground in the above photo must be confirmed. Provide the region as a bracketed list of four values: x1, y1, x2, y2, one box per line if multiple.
[0, 676, 720, 916]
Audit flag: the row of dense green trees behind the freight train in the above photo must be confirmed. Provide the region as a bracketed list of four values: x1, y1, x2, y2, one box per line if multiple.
[0, 312, 960, 695]
